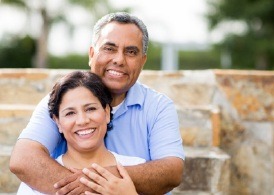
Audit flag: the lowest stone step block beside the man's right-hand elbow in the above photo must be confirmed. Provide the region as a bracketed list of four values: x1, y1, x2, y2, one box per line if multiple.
[172, 147, 230, 195]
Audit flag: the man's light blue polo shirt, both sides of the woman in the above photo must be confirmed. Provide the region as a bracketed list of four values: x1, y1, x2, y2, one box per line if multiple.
[19, 82, 185, 161]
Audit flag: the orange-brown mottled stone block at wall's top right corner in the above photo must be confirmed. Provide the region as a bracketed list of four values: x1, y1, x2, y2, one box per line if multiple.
[215, 70, 274, 121]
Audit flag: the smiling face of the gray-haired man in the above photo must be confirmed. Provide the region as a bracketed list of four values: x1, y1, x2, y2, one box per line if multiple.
[89, 22, 146, 95]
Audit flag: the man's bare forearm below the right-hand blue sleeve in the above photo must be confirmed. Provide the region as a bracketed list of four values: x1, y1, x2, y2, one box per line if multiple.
[125, 157, 184, 195]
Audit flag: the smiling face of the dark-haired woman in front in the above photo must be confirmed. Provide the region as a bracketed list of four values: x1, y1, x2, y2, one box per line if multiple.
[54, 87, 110, 151]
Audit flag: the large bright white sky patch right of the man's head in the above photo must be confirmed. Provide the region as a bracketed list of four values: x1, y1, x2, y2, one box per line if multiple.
[112, 0, 209, 43]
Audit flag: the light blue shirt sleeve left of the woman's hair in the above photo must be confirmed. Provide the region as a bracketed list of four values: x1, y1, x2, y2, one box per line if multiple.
[18, 95, 61, 154]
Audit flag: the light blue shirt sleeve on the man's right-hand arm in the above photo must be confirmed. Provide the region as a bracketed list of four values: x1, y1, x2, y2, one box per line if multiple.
[149, 95, 185, 160]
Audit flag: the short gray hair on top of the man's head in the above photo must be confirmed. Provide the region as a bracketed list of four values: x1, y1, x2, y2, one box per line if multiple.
[92, 12, 149, 54]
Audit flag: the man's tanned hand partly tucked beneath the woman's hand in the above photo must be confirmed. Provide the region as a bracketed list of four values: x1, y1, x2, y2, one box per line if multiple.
[54, 169, 92, 195]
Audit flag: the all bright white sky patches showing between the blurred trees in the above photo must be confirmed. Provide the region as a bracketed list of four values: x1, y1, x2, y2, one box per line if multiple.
[0, 0, 218, 55]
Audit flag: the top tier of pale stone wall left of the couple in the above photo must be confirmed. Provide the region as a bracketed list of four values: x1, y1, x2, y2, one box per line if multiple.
[0, 69, 72, 105]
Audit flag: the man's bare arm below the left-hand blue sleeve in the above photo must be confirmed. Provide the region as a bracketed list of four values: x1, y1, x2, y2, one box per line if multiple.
[10, 139, 72, 194]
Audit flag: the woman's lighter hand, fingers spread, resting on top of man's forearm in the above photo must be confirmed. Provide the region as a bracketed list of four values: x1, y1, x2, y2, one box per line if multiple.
[80, 163, 137, 195]
